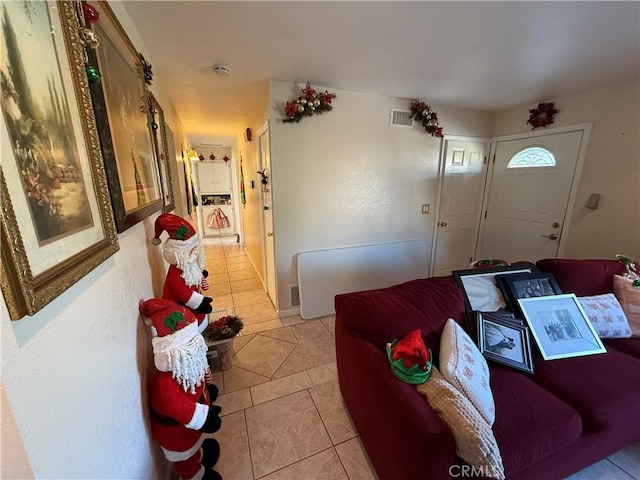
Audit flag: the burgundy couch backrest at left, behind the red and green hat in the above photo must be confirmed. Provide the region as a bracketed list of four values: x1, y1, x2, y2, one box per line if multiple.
[335, 276, 464, 355]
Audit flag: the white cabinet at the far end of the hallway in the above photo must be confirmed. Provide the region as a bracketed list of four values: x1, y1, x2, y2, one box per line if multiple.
[194, 160, 237, 237]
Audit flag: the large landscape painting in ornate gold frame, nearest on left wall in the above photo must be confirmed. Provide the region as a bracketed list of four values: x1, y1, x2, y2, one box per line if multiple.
[0, 2, 118, 320]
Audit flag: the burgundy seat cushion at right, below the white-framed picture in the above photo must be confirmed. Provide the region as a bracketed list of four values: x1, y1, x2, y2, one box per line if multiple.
[533, 348, 640, 439]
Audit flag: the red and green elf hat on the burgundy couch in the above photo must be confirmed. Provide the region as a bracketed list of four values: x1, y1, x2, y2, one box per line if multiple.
[387, 329, 431, 384]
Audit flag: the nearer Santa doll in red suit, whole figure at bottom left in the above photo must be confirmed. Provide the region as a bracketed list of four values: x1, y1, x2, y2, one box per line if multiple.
[140, 298, 222, 480]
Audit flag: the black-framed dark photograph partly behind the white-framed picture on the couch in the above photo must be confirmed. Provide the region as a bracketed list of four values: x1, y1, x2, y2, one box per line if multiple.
[496, 272, 562, 315]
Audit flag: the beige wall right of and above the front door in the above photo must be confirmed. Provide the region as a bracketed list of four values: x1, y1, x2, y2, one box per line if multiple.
[493, 80, 640, 259]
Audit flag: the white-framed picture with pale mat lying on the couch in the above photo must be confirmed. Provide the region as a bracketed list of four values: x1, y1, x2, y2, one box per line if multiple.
[518, 293, 606, 360]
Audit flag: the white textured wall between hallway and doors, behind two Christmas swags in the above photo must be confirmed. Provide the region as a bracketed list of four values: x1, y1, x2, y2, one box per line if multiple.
[270, 81, 493, 310]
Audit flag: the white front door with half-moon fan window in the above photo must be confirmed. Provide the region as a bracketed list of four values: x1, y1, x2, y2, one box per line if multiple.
[477, 127, 588, 262]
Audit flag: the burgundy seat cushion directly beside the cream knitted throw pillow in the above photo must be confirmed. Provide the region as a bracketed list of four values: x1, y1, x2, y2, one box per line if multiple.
[491, 364, 582, 478]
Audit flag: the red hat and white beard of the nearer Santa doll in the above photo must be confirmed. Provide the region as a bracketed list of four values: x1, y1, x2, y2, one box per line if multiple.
[140, 298, 208, 392]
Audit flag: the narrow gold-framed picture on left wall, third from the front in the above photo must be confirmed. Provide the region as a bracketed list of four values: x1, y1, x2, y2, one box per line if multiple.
[149, 93, 176, 212]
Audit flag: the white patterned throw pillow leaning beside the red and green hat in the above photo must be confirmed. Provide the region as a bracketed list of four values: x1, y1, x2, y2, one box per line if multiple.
[440, 318, 496, 425]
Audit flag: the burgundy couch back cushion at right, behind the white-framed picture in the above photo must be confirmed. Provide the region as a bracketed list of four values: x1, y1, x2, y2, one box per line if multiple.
[536, 258, 624, 297]
